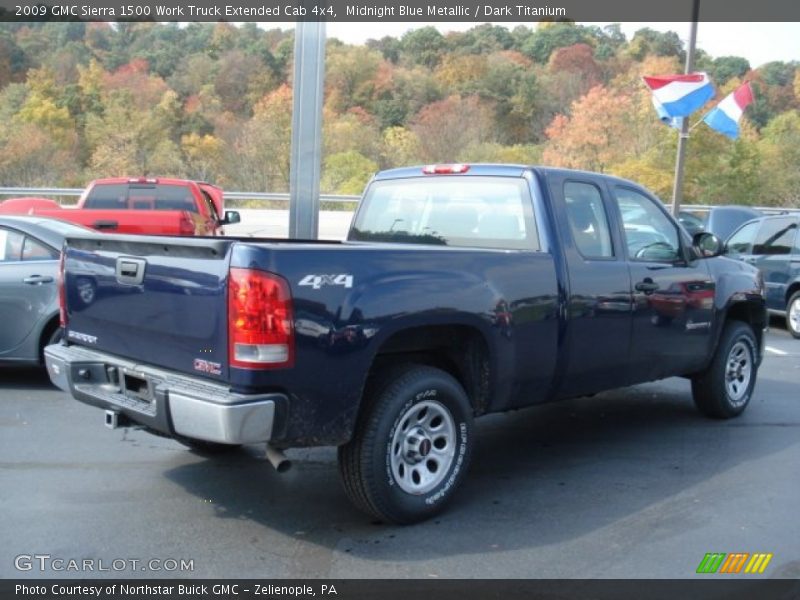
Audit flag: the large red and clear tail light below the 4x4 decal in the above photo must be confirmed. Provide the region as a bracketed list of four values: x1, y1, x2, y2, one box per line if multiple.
[228, 268, 294, 369]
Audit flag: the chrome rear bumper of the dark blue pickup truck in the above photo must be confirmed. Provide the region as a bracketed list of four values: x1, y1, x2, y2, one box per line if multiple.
[45, 344, 286, 444]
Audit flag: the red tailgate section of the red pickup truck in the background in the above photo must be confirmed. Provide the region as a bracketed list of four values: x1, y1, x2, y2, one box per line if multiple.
[31, 208, 193, 235]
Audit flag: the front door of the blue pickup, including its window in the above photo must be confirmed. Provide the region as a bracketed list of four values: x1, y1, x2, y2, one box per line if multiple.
[610, 184, 715, 382]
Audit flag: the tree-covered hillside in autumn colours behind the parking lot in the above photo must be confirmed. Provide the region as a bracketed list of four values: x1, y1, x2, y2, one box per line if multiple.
[0, 23, 800, 206]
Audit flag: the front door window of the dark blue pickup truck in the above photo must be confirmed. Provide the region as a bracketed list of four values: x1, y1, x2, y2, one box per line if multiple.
[614, 186, 680, 262]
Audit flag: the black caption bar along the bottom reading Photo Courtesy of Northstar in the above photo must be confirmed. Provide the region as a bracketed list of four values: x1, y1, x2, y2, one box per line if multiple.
[0, 576, 800, 600]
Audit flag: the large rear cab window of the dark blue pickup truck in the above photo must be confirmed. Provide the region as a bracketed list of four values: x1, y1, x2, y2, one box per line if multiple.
[349, 176, 539, 250]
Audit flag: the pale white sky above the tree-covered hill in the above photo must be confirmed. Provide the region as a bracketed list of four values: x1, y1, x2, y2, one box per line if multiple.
[312, 21, 800, 68]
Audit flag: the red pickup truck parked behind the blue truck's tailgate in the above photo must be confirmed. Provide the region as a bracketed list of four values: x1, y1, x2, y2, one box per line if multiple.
[0, 177, 240, 236]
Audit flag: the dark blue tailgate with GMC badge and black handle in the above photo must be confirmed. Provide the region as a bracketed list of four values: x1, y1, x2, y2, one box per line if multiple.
[65, 235, 235, 379]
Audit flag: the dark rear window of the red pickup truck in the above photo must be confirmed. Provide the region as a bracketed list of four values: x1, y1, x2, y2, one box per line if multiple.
[84, 183, 197, 212]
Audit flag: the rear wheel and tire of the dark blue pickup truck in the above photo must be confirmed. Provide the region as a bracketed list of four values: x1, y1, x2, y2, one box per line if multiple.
[339, 365, 474, 524]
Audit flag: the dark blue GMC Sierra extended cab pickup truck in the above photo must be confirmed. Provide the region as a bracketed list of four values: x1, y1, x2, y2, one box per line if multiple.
[46, 165, 767, 523]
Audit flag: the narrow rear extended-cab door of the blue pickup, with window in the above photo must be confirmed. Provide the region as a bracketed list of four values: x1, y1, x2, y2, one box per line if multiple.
[549, 174, 631, 397]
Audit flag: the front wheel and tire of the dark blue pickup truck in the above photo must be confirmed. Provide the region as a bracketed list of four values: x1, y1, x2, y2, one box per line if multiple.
[692, 321, 758, 419]
